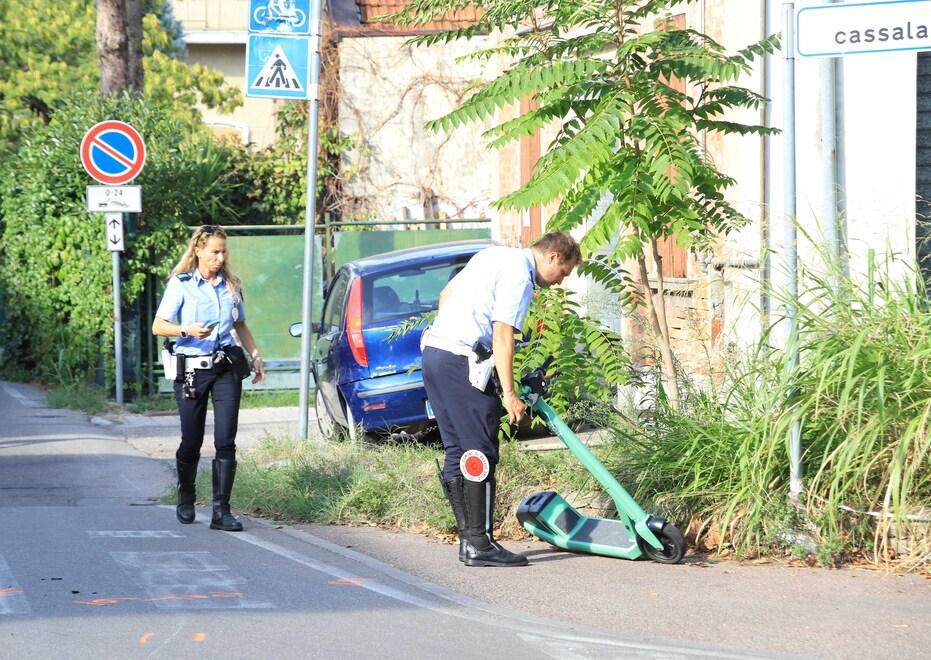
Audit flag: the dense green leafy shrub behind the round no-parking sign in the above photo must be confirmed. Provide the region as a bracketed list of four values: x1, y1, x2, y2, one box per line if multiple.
[0, 92, 244, 380]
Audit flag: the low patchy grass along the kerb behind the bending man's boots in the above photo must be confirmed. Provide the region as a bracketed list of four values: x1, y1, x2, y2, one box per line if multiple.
[212, 436, 593, 537]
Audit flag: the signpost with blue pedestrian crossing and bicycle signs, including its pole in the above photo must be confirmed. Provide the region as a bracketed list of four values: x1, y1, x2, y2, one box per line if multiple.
[246, 0, 322, 440]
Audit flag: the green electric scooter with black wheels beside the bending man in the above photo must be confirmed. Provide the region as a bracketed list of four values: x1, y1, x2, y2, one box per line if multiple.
[517, 359, 685, 564]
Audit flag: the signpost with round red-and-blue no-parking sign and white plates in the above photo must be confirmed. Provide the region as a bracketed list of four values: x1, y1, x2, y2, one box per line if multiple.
[80, 120, 146, 403]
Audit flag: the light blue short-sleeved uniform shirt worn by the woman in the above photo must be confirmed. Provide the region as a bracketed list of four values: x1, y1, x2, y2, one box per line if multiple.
[155, 269, 246, 355]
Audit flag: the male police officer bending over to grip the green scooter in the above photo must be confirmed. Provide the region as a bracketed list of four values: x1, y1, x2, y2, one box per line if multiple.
[423, 232, 581, 566]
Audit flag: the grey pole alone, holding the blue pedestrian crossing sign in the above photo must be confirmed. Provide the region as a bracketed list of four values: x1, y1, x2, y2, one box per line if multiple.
[298, 0, 322, 440]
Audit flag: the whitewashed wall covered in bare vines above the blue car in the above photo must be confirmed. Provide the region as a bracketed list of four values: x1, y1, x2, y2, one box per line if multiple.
[339, 37, 502, 233]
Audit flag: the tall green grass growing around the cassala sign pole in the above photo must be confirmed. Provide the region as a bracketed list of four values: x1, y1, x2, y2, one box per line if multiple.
[596, 253, 931, 570]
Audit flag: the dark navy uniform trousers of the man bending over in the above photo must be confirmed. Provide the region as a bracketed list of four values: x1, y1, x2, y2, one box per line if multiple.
[422, 346, 503, 479]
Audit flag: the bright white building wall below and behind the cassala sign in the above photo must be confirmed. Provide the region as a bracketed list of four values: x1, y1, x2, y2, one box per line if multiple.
[768, 2, 917, 302]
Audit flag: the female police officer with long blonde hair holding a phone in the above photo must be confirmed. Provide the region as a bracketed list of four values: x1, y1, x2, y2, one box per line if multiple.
[152, 225, 265, 532]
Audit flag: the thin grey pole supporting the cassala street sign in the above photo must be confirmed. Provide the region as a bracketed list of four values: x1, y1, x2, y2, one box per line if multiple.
[782, 2, 802, 502]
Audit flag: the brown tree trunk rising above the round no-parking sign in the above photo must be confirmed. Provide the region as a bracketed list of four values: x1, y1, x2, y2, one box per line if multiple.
[97, 0, 142, 96]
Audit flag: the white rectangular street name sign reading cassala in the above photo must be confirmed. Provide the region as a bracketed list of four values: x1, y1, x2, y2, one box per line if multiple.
[795, 0, 931, 57]
